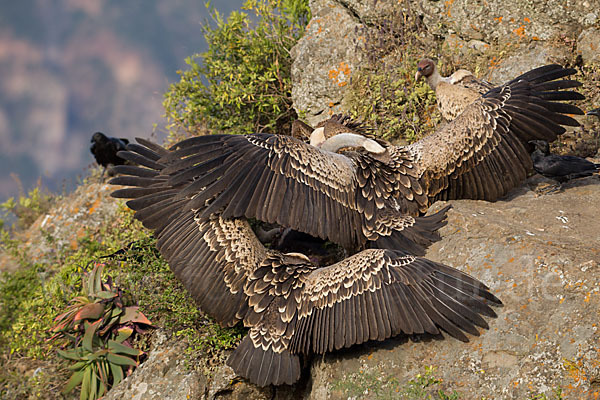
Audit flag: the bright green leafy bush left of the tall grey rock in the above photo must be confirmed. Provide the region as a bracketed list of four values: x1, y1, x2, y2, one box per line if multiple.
[164, 0, 310, 141]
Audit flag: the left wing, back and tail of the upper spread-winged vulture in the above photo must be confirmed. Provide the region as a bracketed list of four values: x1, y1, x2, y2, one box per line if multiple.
[152, 134, 445, 254]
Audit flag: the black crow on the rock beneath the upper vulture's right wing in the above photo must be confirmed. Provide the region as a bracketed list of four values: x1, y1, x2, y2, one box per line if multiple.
[529, 140, 600, 192]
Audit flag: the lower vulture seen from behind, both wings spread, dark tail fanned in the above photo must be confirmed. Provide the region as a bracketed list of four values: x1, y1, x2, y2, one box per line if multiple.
[110, 139, 501, 386]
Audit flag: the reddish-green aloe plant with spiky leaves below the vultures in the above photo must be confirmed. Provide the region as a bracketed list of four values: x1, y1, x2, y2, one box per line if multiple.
[51, 263, 152, 400]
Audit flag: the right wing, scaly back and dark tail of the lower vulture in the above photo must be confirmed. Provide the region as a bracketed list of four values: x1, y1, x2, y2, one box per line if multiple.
[228, 250, 501, 386]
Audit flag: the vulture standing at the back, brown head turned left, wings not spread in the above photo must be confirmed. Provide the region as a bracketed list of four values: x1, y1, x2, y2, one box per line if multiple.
[415, 58, 494, 122]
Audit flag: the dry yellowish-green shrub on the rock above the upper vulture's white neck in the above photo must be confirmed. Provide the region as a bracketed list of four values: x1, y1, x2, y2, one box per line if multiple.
[344, 6, 441, 142]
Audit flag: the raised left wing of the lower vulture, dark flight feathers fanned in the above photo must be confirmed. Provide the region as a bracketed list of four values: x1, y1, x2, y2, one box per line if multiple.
[110, 139, 268, 326]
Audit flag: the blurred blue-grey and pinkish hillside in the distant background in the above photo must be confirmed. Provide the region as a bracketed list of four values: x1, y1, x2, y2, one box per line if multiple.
[0, 0, 242, 202]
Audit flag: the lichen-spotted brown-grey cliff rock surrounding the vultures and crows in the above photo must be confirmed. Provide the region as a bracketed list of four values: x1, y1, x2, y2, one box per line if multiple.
[2, 0, 600, 399]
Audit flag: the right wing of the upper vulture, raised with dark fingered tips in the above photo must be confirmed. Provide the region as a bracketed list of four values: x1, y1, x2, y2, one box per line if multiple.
[404, 65, 583, 208]
